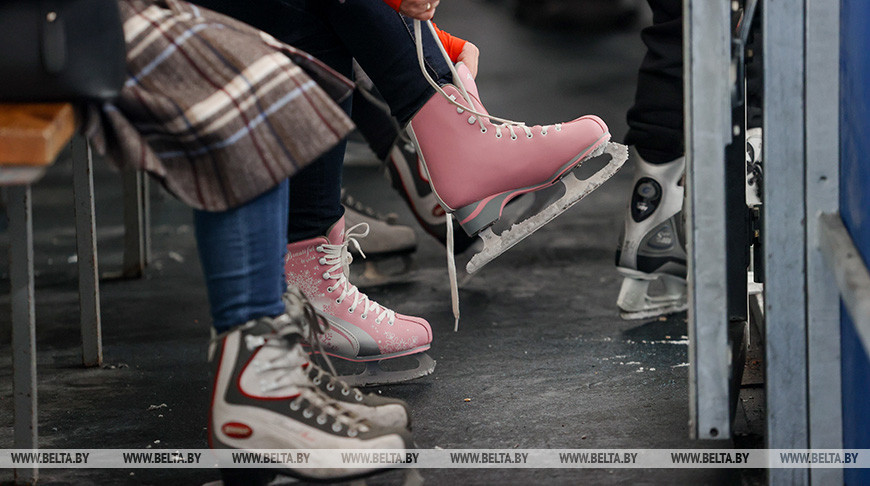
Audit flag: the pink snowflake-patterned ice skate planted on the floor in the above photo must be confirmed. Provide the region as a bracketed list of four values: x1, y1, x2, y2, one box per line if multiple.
[284, 217, 435, 386]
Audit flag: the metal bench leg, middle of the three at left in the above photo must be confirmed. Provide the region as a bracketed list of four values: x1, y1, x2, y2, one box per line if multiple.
[72, 136, 103, 366]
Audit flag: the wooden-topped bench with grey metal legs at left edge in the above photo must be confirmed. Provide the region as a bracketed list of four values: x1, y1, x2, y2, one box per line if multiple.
[0, 103, 103, 483]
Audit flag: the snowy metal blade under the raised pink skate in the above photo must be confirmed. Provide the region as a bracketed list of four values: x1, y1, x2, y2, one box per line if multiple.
[465, 142, 628, 274]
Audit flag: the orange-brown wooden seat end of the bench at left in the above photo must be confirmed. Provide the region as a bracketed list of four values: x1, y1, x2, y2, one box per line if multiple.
[0, 103, 76, 166]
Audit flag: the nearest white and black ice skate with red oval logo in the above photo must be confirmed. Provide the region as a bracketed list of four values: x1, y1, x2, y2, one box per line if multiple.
[208, 314, 412, 484]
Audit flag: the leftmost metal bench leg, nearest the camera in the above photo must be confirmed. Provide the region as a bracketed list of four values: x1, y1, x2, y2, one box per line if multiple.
[8, 185, 38, 484]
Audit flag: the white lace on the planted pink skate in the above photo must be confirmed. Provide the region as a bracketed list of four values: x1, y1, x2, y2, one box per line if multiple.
[317, 223, 396, 326]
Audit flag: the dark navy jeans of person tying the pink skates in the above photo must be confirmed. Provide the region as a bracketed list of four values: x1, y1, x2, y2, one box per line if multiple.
[194, 0, 451, 242]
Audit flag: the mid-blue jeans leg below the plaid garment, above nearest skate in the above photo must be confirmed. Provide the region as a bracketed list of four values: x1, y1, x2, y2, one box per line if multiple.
[193, 180, 288, 332]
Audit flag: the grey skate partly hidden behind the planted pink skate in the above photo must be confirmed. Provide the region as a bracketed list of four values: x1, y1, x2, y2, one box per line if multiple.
[341, 192, 417, 288]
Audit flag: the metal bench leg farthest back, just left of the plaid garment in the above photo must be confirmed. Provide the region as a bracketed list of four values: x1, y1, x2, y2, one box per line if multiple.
[121, 171, 151, 278]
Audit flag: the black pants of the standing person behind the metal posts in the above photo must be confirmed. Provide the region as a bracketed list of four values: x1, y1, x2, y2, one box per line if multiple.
[625, 0, 762, 163]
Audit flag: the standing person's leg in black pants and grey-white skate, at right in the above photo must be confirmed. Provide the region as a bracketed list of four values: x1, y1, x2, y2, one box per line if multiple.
[616, 0, 686, 319]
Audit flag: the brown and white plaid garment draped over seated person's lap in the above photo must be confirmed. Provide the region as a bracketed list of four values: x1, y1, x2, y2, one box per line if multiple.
[92, 0, 353, 211]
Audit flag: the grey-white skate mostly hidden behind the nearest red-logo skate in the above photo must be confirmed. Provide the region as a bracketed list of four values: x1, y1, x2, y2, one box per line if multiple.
[284, 286, 411, 430]
